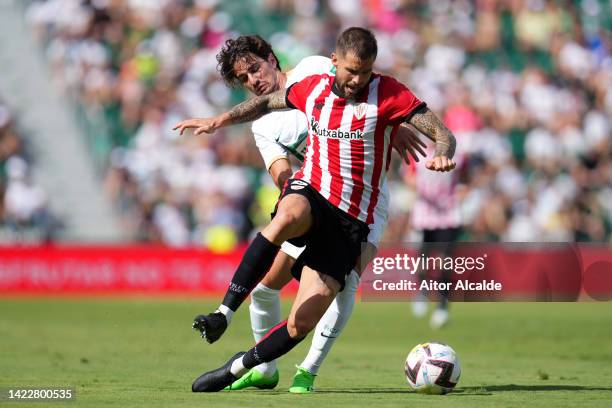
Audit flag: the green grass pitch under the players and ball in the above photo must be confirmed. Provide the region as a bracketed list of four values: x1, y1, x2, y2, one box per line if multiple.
[0, 298, 612, 408]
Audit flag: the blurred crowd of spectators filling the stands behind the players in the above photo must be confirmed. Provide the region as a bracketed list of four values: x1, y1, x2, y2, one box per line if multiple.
[26, 0, 612, 250]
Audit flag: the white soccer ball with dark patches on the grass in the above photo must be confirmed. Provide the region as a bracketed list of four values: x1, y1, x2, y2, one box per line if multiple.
[404, 343, 461, 395]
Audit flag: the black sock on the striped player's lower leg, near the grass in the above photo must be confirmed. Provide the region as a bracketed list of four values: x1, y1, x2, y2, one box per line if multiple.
[242, 320, 306, 369]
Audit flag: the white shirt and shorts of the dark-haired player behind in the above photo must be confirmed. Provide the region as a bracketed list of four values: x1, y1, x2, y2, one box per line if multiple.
[251, 56, 389, 252]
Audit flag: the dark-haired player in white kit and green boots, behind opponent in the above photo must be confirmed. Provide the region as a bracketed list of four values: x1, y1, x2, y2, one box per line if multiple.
[183, 35, 425, 393]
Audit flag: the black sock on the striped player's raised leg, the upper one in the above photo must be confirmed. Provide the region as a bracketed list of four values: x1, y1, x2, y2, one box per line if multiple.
[223, 234, 280, 312]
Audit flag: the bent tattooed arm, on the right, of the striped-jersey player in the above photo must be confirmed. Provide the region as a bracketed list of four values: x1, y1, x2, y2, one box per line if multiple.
[408, 108, 457, 171]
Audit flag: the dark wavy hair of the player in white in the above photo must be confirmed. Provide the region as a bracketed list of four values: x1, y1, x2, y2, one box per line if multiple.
[217, 35, 280, 87]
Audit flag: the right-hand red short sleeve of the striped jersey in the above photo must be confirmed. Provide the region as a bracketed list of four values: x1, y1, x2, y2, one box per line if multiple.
[380, 76, 427, 126]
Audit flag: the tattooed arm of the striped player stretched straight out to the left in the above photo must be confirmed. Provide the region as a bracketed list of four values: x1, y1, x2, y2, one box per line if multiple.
[172, 89, 287, 135]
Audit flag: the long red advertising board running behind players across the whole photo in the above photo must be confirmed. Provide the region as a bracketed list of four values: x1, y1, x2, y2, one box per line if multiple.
[0, 243, 612, 301]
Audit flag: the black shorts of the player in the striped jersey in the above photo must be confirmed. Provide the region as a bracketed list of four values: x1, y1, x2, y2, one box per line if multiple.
[272, 179, 370, 289]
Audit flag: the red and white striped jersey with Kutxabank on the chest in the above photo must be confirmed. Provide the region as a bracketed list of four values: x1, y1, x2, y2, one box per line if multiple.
[287, 74, 424, 224]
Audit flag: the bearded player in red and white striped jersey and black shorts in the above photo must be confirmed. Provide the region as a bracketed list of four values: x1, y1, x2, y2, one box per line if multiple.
[175, 27, 455, 392]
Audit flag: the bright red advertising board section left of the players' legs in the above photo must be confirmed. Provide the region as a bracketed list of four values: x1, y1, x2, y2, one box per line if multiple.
[0, 246, 297, 294]
